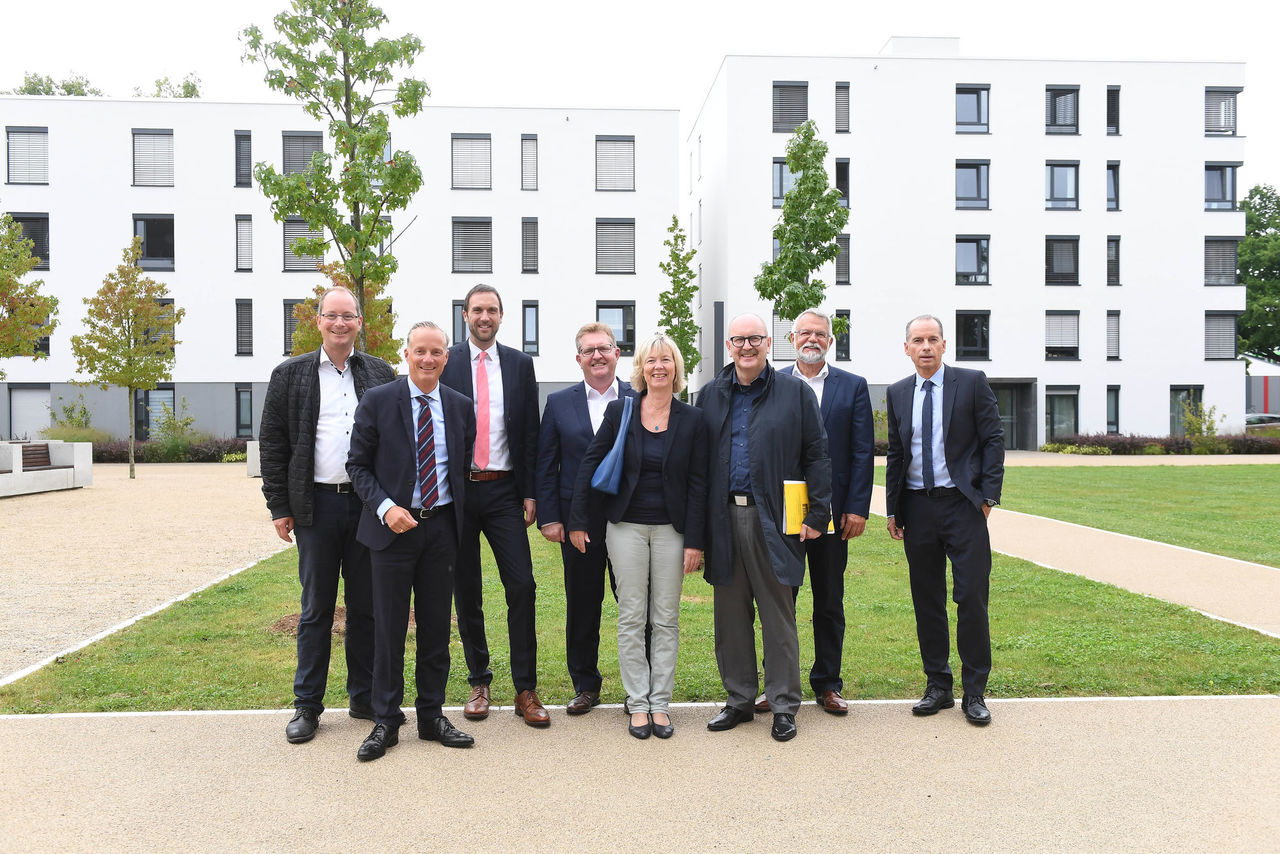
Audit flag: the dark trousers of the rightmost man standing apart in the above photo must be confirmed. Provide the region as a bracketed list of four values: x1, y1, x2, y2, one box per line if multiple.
[902, 490, 991, 694]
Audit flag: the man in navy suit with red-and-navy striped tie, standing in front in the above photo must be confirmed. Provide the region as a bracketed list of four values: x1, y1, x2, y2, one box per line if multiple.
[347, 321, 475, 762]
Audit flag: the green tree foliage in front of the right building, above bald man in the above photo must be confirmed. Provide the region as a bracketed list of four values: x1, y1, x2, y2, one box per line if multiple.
[755, 120, 849, 330]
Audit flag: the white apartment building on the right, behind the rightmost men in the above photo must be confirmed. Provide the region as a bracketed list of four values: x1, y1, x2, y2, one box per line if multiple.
[680, 40, 1244, 448]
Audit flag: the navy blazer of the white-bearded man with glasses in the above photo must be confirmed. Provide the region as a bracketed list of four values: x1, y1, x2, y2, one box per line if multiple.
[778, 365, 876, 522]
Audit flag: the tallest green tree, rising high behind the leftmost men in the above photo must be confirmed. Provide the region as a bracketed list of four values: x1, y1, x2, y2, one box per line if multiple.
[242, 0, 429, 352]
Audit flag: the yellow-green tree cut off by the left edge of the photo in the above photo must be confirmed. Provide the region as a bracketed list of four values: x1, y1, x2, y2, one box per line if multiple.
[0, 214, 58, 380]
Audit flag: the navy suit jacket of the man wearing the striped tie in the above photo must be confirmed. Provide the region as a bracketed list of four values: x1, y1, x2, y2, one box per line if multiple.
[347, 376, 476, 551]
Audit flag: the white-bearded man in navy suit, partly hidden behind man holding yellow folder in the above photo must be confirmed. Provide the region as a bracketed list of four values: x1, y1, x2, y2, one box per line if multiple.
[773, 311, 876, 714]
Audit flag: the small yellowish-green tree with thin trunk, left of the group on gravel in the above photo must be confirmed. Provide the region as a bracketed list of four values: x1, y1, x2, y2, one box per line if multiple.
[72, 237, 187, 479]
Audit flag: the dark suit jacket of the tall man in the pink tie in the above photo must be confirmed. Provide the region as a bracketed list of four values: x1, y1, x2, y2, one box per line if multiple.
[440, 341, 538, 498]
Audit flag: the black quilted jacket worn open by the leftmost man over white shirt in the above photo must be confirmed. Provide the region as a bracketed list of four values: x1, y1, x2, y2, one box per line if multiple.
[257, 350, 396, 525]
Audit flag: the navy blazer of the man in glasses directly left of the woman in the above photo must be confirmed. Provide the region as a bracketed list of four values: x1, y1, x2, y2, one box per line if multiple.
[538, 379, 631, 528]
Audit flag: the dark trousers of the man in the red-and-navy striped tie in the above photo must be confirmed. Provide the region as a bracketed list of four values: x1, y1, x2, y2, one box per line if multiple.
[372, 504, 458, 726]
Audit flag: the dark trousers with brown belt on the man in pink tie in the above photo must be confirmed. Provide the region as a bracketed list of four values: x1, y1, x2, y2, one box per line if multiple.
[453, 478, 538, 693]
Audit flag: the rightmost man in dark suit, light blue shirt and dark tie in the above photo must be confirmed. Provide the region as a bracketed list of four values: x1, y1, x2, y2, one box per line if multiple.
[884, 315, 1005, 726]
